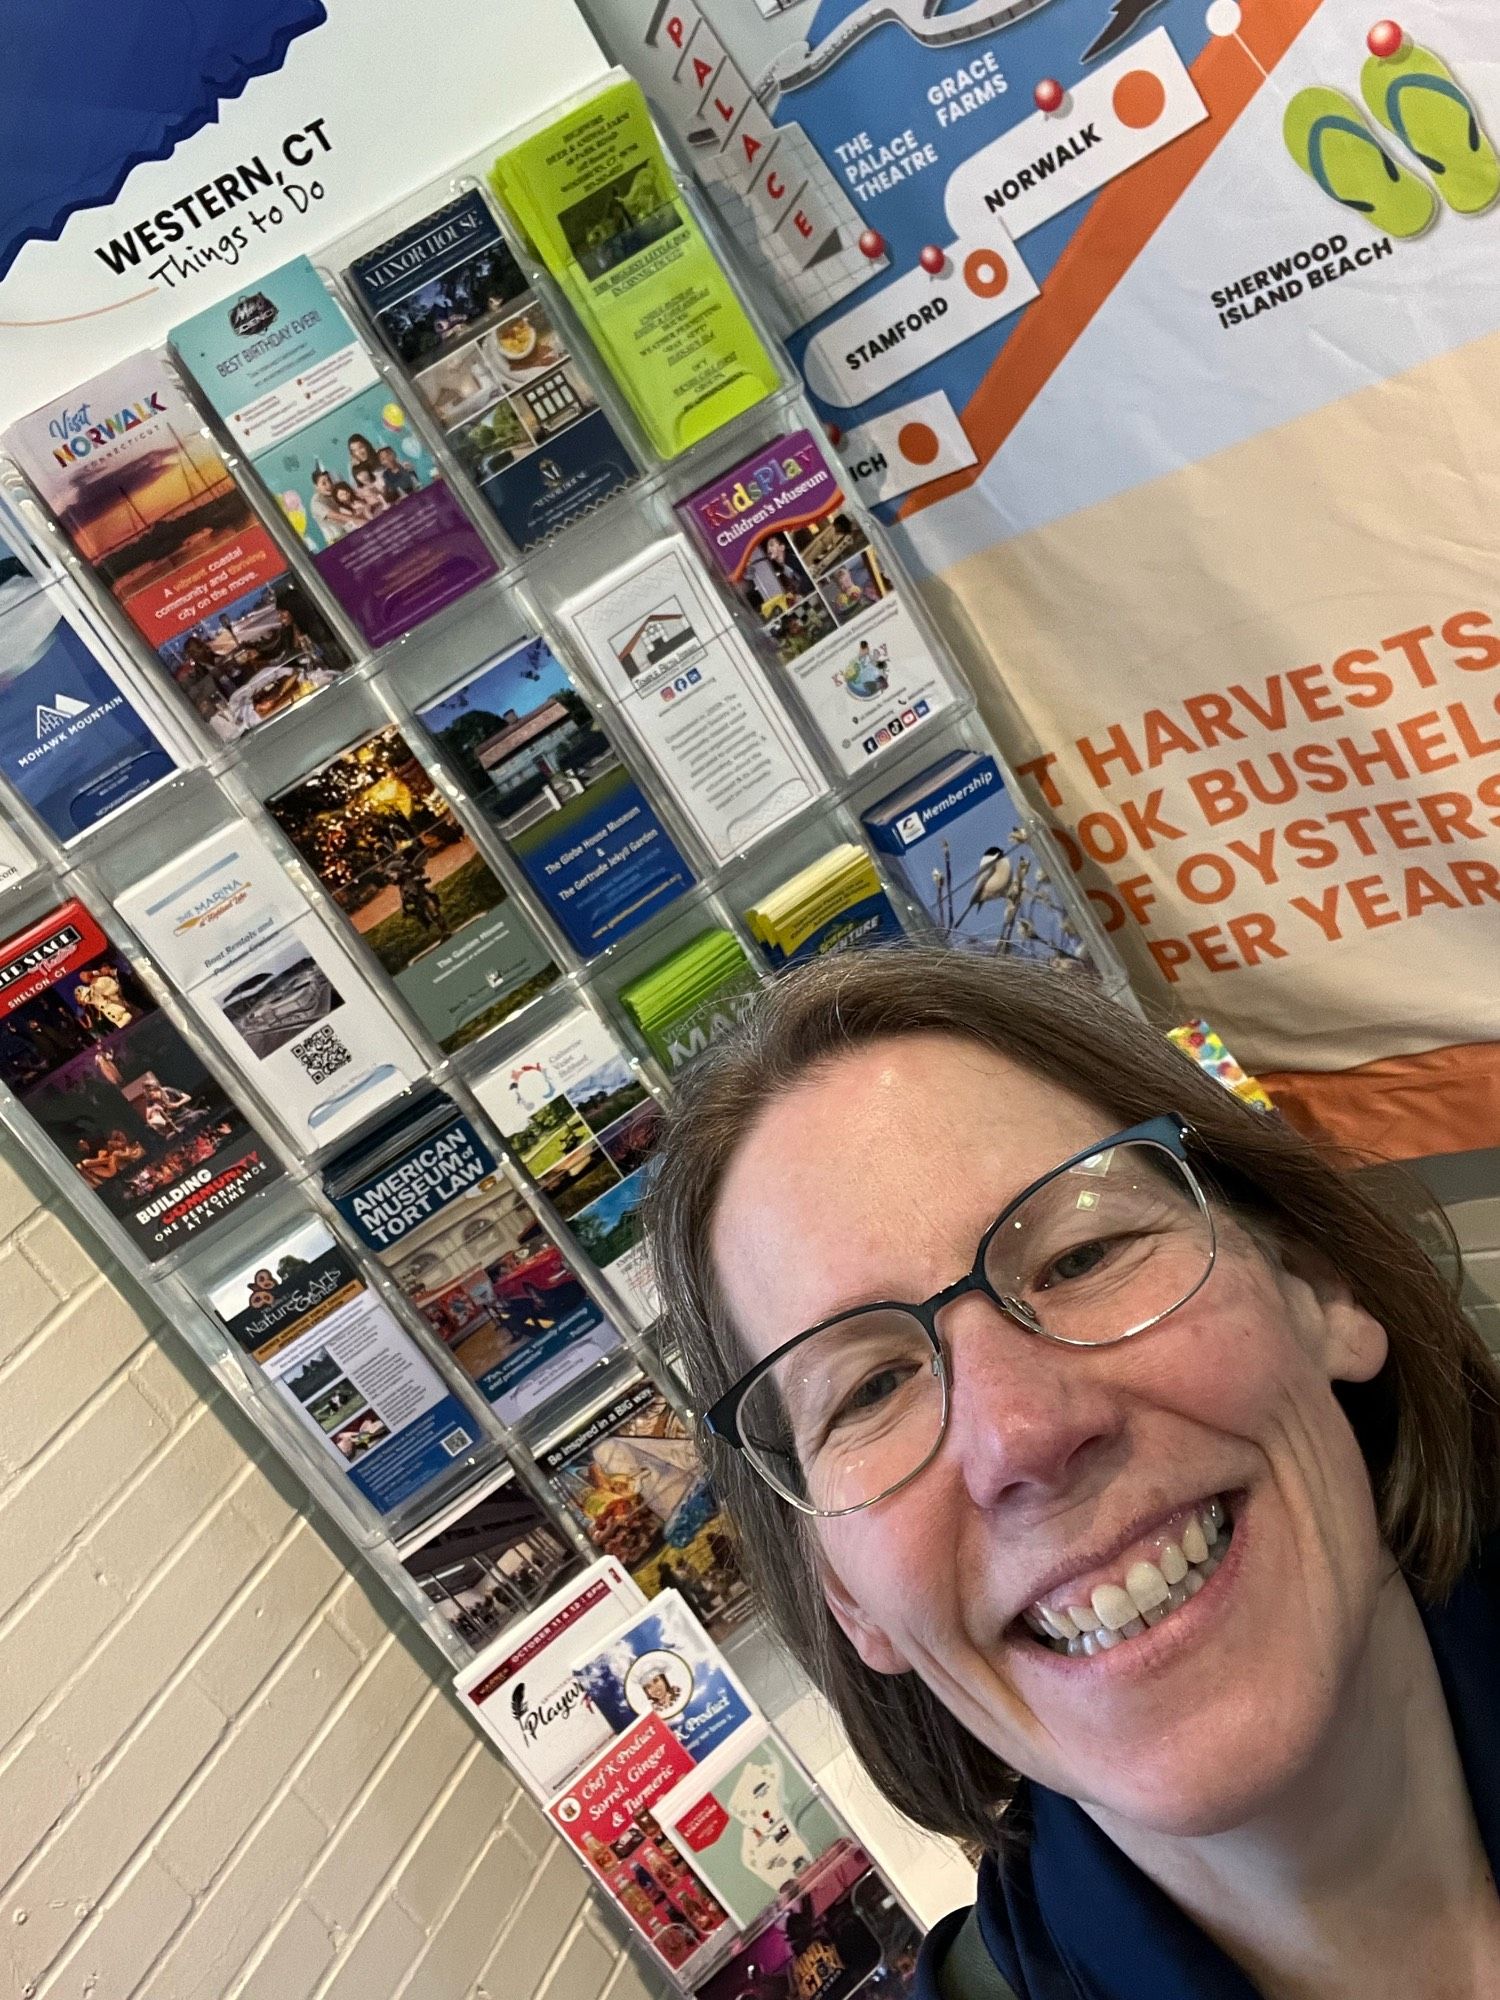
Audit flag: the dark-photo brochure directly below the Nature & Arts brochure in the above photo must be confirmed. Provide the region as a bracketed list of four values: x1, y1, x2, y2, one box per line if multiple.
[396, 1470, 578, 1652]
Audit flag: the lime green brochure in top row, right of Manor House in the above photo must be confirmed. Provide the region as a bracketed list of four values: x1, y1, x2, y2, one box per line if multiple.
[490, 78, 780, 458]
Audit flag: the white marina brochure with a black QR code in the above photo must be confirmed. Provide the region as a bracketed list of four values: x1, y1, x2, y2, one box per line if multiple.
[116, 820, 424, 1148]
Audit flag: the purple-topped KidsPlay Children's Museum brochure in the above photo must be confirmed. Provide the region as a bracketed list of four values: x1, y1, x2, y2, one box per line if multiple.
[680, 430, 954, 774]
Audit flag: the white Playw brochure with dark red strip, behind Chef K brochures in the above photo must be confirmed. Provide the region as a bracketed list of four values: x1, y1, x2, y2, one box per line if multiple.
[454, 1556, 642, 1798]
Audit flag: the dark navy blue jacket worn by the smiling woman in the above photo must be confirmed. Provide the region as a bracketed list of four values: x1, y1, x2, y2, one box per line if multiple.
[916, 1536, 1500, 2000]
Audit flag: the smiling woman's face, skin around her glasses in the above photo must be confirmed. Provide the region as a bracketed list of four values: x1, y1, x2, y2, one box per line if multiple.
[714, 1034, 1390, 1834]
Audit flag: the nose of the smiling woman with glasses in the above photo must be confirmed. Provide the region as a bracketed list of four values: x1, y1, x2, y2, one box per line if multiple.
[944, 1298, 1126, 1508]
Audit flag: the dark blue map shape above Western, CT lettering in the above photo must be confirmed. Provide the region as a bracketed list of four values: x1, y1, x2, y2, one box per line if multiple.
[0, 0, 328, 278]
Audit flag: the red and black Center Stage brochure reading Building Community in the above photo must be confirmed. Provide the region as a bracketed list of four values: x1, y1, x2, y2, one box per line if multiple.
[0, 902, 282, 1262]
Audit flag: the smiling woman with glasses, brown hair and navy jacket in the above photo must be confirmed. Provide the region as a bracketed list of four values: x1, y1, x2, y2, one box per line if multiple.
[650, 952, 1500, 2000]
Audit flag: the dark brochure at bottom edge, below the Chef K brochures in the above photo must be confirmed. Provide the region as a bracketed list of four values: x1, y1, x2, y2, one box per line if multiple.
[694, 1840, 922, 2000]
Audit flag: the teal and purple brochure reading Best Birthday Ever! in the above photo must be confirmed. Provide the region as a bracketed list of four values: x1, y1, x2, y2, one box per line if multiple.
[172, 256, 496, 646]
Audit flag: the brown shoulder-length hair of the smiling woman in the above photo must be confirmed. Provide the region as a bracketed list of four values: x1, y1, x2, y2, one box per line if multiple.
[648, 948, 1500, 1848]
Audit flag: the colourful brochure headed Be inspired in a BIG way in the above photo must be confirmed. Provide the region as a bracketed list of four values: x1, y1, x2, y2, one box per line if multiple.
[536, 1376, 750, 1638]
